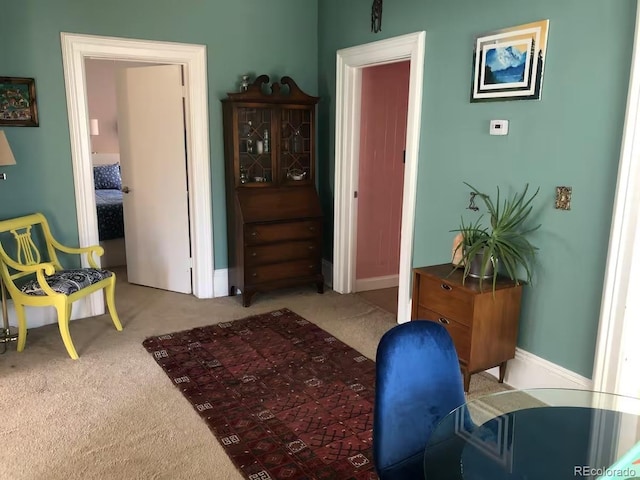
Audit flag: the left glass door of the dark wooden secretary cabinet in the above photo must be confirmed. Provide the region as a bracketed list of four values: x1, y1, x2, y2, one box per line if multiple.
[236, 107, 274, 186]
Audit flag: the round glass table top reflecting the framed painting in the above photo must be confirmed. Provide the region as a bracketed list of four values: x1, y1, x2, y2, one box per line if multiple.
[424, 389, 640, 480]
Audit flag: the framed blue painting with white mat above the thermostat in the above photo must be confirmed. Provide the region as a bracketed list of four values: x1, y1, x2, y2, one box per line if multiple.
[471, 20, 549, 102]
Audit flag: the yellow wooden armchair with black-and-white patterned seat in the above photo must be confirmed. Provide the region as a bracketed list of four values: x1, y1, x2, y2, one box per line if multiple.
[0, 213, 122, 360]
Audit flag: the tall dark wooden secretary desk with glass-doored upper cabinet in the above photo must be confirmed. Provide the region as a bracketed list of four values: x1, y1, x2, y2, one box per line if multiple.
[222, 75, 324, 307]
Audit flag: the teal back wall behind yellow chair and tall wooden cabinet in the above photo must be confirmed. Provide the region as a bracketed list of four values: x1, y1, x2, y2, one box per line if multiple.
[0, 0, 318, 268]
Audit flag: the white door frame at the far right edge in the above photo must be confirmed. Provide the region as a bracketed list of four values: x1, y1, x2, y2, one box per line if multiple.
[593, 0, 640, 396]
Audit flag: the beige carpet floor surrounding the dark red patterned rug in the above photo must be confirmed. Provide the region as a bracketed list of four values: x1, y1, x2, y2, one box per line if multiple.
[0, 275, 504, 480]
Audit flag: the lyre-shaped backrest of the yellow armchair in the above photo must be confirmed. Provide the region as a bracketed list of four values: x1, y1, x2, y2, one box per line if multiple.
[0, 213, 62, 283]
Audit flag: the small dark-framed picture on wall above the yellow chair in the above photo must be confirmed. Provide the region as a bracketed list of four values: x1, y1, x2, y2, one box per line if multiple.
[0, 77, 38, 127]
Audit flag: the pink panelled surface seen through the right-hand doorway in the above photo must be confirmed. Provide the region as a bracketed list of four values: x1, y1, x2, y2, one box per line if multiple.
[356, 61, 410, 284]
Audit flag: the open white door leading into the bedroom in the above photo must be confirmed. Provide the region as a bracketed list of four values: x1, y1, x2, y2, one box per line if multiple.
[116, 65, 191, 293]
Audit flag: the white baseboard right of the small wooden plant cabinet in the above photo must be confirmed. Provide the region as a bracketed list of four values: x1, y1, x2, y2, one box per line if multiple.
[487, 348, 593, 390]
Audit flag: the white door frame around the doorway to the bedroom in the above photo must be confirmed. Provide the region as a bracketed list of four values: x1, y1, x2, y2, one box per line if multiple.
[60, 32, 214, 316]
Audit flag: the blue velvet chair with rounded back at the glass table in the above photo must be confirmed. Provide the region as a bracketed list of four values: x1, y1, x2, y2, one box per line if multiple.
[373, 320, 465, 480]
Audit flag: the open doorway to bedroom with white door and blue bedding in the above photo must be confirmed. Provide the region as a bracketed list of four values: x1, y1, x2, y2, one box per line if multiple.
[85, 60, 192, 294]
